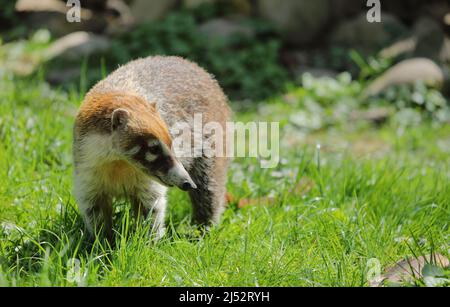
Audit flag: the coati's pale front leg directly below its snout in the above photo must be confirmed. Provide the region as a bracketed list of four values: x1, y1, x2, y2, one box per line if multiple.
[131, 184, 167, 240]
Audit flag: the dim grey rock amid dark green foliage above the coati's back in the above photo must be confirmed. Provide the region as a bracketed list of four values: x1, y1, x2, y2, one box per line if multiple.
[199, 18, 254, 39]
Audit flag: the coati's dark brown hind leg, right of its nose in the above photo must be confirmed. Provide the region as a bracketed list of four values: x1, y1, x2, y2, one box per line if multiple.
[189, 157, 228, 226]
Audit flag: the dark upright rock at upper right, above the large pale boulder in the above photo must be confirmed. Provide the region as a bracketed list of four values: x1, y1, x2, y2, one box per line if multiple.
[413, 17, 445, 61]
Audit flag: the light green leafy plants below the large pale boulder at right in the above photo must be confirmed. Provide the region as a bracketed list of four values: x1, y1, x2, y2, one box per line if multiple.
[284, 72, 450, 130]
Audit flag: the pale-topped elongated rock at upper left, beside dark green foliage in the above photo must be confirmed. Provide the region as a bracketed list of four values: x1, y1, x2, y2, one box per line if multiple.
[45, 31, 110, 60]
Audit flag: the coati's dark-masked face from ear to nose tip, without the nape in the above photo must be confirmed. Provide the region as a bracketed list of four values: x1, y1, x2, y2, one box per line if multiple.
[111, 108, 197, 191]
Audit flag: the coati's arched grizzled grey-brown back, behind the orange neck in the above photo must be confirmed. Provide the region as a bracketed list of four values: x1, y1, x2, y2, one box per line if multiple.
[88, 56, 230, 127]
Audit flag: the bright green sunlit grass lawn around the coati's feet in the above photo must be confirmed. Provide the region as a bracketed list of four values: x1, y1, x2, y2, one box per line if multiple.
[0, 73, 450, 286]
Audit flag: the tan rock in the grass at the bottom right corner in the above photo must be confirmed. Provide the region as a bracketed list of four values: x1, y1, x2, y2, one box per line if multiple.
[369, 254, 449, 287]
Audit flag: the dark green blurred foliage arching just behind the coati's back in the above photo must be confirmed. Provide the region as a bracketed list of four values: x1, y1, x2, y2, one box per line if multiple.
[107, 11, 288, 99]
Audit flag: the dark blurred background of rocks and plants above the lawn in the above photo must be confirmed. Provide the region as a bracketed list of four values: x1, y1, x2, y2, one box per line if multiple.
[0, 0, 450, 105]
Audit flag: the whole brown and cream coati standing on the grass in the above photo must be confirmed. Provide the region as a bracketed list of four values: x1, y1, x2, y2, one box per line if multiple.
[73, 56, 230, 239]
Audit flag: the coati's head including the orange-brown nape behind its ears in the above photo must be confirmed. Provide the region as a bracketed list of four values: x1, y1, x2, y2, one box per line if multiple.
[77, 93, 196, 190]
